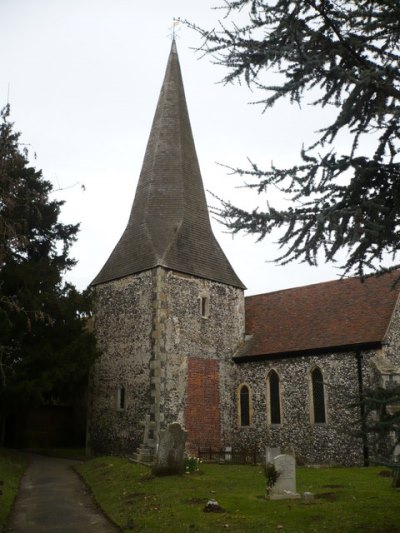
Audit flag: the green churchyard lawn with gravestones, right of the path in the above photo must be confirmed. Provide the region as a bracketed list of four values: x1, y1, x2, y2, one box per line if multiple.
[77, 457, 400, 533]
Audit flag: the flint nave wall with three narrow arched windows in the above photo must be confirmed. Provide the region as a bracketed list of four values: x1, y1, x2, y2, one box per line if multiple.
[231, 352, 374, 465]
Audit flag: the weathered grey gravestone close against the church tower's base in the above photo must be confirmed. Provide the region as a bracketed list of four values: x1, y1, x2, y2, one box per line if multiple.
[152, 423, 187, 476]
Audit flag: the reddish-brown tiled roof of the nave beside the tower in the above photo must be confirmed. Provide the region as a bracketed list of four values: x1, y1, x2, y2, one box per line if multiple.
[244, 271, 400, 357]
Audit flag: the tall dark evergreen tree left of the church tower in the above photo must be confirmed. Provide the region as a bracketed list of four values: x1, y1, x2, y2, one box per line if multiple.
[0, 106, 96, 444]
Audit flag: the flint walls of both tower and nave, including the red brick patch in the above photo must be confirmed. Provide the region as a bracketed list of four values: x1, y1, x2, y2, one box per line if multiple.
[88, 267, 400, 465]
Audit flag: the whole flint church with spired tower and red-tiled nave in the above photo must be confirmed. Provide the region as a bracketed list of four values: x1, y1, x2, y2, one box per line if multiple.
[88, 42, 400, 465]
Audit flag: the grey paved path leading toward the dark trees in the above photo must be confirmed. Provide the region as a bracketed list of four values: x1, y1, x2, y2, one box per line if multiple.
[8, 454, 120, 533]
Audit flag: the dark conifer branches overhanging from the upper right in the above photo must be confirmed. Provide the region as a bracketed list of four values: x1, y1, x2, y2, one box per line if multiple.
[186, 0, 400, 277]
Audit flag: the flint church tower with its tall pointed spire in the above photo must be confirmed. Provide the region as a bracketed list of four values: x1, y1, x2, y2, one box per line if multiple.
[88, 42, 244, 454]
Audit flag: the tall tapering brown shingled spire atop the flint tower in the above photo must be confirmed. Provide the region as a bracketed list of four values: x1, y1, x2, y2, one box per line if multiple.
[92, 41, 244, 288]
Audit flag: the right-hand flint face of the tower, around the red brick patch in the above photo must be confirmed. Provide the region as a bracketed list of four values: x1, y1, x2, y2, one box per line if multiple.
[159, 271, 244, 446]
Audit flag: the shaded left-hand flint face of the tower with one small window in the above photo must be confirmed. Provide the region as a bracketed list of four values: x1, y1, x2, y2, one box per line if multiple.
[88, 271, 154, 454]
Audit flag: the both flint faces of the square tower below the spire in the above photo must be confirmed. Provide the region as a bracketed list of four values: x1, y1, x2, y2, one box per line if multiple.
[88, 267, 244, 454]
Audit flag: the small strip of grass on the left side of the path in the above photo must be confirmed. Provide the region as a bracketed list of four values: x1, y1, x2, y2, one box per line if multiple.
[0, 448, 28, 530]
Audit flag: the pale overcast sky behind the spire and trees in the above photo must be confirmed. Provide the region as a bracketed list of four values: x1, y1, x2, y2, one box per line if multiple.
[0, 0, 348, 294]
